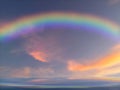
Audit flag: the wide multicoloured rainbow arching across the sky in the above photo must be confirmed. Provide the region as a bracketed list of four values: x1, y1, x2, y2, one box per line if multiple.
[0, 12, 120, 41]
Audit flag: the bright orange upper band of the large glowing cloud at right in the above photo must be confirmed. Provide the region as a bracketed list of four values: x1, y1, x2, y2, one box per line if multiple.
[68, 45, 120, 71]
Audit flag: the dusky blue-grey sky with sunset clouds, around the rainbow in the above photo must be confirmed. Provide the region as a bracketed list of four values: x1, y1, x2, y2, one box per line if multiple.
[0, 0, 120, 86]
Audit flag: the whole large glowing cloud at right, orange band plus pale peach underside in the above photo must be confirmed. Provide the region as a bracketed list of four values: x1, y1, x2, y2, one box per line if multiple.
[67, 44, 120, 81]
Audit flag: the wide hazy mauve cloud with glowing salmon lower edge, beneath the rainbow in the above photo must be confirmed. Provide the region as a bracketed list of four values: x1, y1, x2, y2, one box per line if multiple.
[24, 34, 61, 62]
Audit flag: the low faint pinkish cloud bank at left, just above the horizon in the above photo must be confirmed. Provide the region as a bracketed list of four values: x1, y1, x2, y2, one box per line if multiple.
[0, 67, 55, 78]
